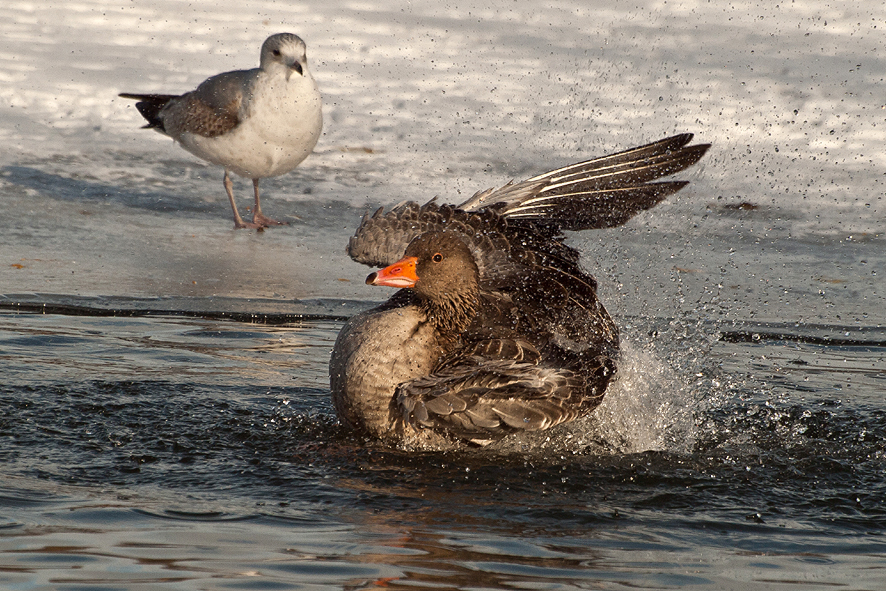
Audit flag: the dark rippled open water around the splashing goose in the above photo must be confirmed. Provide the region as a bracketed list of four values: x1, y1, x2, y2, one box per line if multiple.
[0, 314, 886, 589]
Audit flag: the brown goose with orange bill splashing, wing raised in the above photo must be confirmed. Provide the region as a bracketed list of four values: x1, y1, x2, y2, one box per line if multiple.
[330, 134, 709, 447]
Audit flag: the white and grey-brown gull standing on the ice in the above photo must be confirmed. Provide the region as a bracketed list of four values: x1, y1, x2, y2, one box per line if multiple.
[120, 33, 323, 230]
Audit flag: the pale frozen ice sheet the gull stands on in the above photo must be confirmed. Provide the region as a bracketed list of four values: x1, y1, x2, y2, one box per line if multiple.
[0, 0, 886, 324]
